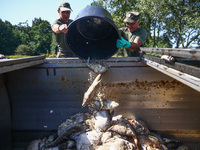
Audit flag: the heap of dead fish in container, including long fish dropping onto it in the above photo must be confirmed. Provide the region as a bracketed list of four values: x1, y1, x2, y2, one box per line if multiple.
[27, 62, 189, 150]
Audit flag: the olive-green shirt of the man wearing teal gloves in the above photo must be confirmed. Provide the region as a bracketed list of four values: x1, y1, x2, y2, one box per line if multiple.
[116, 27, 147, 57]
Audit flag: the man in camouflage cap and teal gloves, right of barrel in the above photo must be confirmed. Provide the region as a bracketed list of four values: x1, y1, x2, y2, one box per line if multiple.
[116, 12, 147, 57]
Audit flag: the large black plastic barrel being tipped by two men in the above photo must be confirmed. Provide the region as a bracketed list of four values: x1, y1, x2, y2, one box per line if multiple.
[65, 6, 120, 60]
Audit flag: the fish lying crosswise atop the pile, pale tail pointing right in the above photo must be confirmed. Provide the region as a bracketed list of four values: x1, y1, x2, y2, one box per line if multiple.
[91, 99, 119, 110]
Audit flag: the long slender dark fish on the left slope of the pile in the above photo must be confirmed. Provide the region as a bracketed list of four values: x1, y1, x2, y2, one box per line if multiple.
[42, 125, 83, 149]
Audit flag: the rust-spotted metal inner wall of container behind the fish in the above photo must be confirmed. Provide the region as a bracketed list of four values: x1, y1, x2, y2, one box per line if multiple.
[3, 58, 200, 149]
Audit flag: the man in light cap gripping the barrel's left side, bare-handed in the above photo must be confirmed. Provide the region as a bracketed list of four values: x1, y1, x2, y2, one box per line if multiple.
[51, 1, 74, 58]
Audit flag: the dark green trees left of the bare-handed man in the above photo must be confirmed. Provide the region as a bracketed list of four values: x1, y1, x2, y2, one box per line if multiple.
[0, 18, 52, 55]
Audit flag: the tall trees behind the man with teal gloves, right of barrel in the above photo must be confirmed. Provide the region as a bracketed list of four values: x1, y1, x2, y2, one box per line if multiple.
[92, 0, 200, 48]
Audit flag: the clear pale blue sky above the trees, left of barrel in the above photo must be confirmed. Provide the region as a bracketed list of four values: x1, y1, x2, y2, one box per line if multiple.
[0, 0, 93, 26]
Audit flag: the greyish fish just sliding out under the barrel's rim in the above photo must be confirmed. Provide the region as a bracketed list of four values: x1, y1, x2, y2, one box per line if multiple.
[86, 58, 109, 74]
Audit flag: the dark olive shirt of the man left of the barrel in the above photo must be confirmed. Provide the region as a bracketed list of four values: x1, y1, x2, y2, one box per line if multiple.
[51, 19, 73, 52]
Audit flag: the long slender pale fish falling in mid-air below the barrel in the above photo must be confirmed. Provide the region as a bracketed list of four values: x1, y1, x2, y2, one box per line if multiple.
[82, 74, 102, 107]
